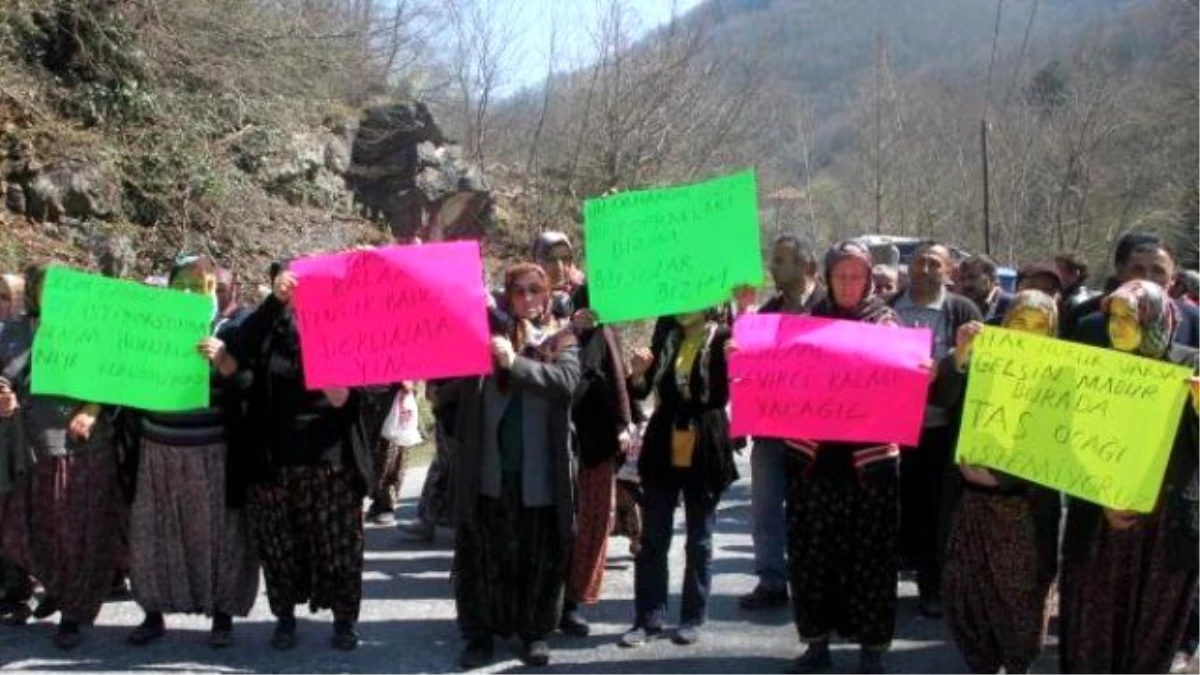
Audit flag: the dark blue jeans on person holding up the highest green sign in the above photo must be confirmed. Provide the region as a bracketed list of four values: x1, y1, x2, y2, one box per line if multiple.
[634, 470, 716, 628]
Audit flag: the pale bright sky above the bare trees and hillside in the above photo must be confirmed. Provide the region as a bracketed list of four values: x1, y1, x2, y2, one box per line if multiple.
[502, 0, 702, 94]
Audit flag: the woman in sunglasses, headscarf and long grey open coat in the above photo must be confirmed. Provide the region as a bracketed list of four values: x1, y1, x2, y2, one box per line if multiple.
[451, 263, 580, 669]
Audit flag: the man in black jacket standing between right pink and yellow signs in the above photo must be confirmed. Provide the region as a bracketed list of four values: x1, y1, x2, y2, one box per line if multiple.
[892, 241, 983, 619]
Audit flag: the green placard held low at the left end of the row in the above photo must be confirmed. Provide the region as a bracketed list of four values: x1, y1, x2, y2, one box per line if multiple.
[31, 268, 212, 411]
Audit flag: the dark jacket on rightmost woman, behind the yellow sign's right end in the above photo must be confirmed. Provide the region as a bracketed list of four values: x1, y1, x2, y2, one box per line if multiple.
[1062, 345, 1200, 572]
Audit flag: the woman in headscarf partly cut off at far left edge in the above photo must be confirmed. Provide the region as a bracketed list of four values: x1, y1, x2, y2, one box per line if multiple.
[0, 269, 34, 625]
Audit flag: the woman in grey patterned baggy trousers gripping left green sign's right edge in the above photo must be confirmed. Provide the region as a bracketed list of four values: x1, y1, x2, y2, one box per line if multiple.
[128, 256, 258, 647]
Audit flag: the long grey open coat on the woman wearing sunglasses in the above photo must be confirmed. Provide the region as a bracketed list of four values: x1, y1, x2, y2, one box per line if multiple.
[448, 344, 581, 545]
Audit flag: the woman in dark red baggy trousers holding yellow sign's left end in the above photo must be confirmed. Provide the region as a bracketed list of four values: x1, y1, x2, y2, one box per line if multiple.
[938, 291, 1062, 675]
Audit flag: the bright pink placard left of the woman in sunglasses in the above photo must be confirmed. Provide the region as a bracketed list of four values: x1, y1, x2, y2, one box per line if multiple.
[292, 241, 492, 389]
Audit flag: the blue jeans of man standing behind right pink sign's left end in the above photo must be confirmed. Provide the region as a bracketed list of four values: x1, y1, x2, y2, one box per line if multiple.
[750, 438, 788, 591]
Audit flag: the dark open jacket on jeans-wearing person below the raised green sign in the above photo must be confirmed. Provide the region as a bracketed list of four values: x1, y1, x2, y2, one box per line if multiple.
[632, 319, 738, 504]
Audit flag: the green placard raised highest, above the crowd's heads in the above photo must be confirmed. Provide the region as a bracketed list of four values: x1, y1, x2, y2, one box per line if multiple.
[583, 171, 763, 323]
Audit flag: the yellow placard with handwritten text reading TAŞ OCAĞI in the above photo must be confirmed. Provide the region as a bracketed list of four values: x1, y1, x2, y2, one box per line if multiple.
[958, 328, 1192, 513]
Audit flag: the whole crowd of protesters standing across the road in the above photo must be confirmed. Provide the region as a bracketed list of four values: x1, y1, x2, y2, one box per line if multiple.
[0, 227, 1200, 675]
